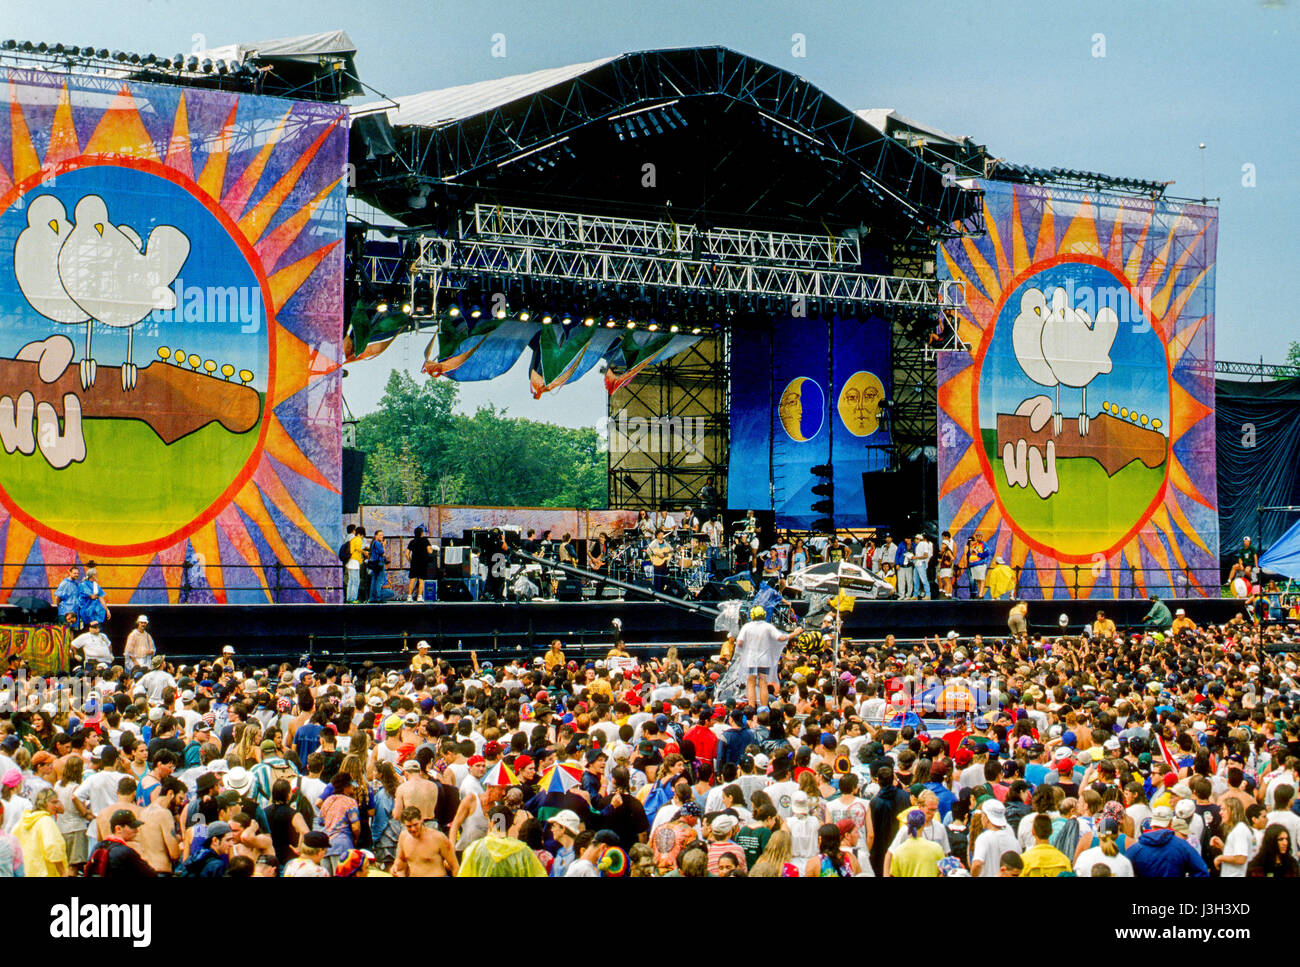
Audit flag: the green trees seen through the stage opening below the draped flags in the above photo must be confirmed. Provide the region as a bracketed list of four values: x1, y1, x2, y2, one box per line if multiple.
[356, 370, 608, 508]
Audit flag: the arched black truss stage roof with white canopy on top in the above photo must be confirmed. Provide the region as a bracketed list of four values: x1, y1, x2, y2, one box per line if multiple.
[352, 47, 979, 240]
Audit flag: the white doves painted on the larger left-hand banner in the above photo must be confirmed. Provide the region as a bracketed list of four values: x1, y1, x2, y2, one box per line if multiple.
[14, 195, 190, 390]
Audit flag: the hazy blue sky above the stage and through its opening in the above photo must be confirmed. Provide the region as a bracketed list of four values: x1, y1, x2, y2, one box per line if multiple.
[0, 0, 1300, 425]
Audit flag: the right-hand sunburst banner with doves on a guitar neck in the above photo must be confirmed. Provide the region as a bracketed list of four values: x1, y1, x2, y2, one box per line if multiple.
[937, 182, 1219, 598]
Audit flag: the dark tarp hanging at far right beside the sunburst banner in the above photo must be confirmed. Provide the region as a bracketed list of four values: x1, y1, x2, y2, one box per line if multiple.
[1214, 380, 1300, 554]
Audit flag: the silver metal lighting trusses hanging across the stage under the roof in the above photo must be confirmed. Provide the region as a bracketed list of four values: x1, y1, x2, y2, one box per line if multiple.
[413, 207, 965, 311]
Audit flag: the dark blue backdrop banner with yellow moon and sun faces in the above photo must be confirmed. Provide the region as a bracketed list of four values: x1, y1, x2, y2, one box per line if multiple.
[728, 316, 889, 529]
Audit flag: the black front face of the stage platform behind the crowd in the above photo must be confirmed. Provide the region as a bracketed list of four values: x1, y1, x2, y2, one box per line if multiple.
[0, 598, 1258, 659]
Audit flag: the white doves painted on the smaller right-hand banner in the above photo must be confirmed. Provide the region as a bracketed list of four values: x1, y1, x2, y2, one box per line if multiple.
[1011, 286, 1119, 437]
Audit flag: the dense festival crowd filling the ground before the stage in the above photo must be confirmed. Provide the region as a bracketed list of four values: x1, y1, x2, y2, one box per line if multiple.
[0, 597, 1300, 877]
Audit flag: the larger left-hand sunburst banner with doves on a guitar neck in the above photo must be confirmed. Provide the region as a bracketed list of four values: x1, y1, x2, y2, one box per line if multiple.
[0, 70, 347, 603]
